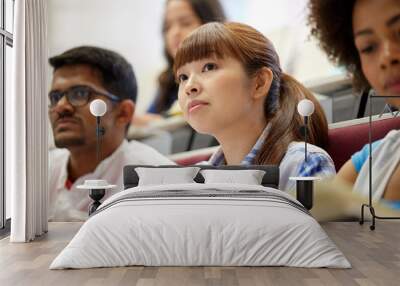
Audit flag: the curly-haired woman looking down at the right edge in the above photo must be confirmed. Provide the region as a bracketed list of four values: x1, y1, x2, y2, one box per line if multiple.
[309, 0, 400, 208]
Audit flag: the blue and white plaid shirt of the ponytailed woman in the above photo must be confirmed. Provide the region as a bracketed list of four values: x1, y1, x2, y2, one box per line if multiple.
[208, 125, 336, 191]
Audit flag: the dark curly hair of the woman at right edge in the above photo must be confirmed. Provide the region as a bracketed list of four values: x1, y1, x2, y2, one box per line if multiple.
[308, 0, 370, 90]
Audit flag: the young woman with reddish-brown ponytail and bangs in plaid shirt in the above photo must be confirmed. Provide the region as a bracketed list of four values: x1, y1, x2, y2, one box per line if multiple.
[174, 23, 335, 190]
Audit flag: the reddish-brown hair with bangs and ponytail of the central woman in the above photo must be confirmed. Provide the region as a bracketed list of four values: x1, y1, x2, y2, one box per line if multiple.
[174, 23, 328, 165]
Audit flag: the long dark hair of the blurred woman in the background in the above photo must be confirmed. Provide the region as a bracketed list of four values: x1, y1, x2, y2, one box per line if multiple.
[156, 0, 225, 113]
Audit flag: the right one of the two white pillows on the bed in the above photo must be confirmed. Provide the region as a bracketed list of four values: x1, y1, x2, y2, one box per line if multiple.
[200, 169, 265, 185]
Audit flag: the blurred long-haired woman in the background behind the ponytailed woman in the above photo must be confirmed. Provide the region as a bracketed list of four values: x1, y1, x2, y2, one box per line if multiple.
[133, 0, 225, 125]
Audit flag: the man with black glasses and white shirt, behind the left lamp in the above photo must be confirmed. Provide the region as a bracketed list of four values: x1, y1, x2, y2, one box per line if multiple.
[49, 46, 173, 221]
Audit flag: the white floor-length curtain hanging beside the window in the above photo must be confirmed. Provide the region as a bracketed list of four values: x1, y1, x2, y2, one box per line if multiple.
[6, 0, 48, 242]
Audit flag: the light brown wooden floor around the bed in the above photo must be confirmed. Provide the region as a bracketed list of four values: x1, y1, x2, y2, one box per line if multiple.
[0, 221, 400, 286]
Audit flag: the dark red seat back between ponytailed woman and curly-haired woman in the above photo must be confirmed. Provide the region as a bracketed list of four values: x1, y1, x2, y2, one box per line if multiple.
[326, 117, 400, 171]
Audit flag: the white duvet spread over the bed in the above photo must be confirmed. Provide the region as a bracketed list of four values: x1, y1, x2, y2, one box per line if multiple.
[50, 183, 350, 269]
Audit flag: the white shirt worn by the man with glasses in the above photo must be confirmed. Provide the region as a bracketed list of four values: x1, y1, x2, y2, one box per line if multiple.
[49, 140, 175, 221]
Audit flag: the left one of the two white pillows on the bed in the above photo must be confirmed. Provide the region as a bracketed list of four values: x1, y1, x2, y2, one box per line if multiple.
[135, 167, 200, 186]
